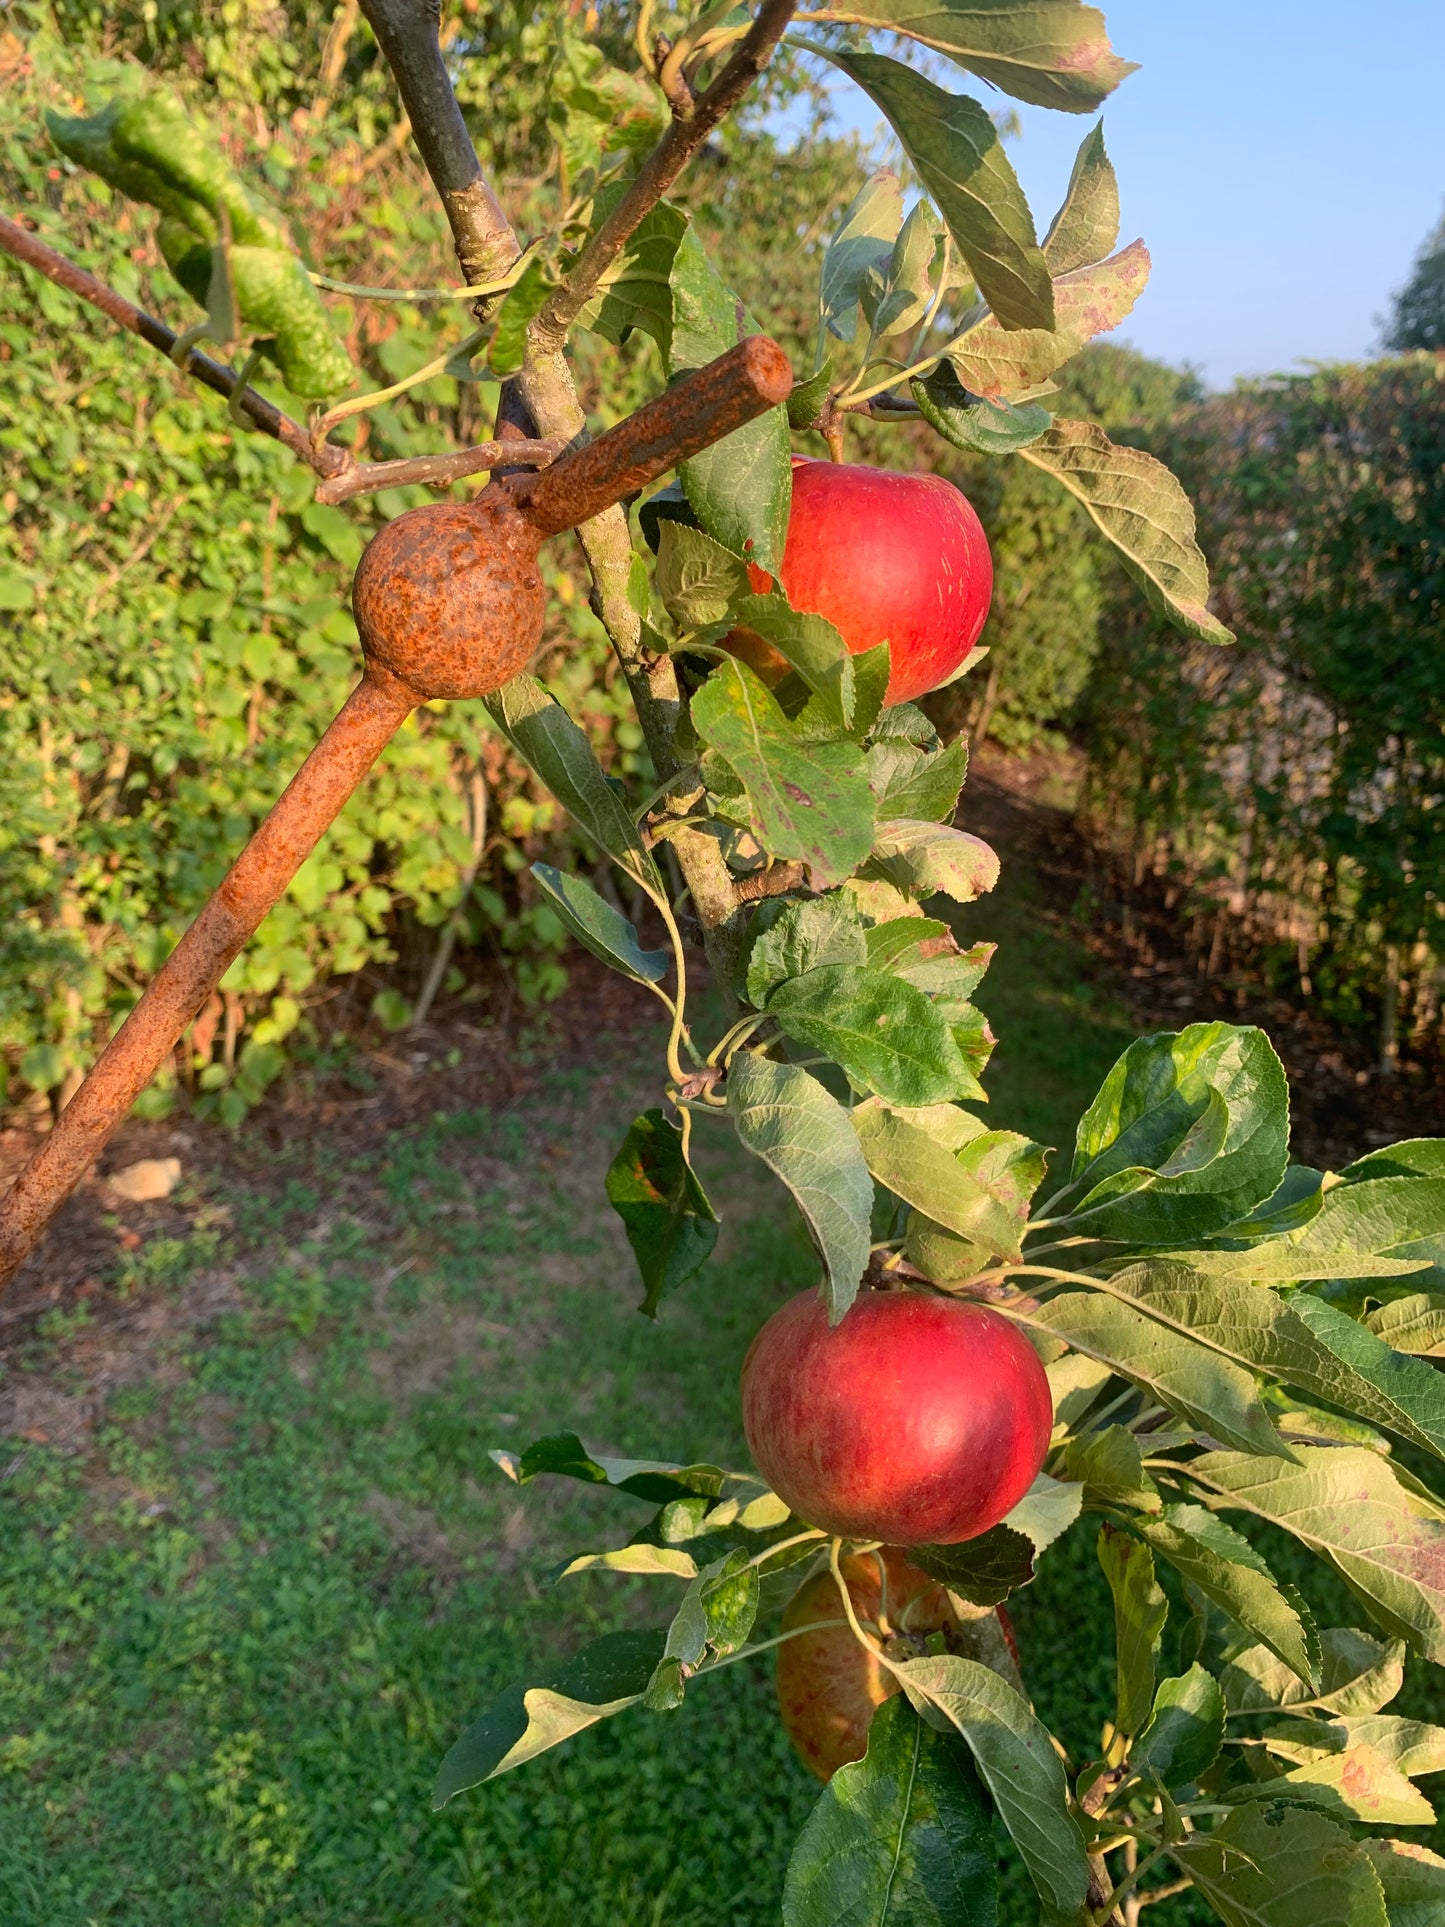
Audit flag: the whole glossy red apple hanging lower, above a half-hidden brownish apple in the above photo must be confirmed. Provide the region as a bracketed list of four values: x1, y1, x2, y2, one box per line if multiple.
[742, 1291, 1054, 1545]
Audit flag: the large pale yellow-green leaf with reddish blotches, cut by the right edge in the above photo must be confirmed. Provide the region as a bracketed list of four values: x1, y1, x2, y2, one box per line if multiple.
[1181, 1445, 1445, 1665]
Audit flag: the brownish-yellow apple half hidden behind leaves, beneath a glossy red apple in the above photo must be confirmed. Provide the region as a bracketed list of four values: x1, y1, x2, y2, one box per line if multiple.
[778, 1545, 958, 1781]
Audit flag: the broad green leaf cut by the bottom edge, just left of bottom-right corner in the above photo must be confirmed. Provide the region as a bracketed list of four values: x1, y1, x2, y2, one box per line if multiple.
[1169, 1800, 1391, 1927]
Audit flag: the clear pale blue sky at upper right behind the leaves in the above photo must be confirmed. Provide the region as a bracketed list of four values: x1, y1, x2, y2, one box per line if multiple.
[805, 0, 1445, 387]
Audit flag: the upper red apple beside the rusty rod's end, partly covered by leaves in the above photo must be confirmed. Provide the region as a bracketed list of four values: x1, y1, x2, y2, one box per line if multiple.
[728, 455, 994, 703]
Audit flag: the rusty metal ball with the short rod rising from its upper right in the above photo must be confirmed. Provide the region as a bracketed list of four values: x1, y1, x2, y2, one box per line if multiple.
[351, 335, 792, 701]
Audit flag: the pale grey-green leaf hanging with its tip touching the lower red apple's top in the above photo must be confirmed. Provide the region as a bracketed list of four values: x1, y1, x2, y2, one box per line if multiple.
[726, 1052, 873, 1324]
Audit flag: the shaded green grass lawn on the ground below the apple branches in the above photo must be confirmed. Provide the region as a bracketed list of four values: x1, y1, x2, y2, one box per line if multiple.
[0, 851, 1441, 1927]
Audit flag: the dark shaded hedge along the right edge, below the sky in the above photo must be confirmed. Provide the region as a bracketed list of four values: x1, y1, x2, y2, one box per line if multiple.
[1090, 356, 1445, 1041]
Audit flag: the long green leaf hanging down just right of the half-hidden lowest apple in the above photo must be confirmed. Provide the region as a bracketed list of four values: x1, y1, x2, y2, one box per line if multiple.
[898, 1653, 1089, 1919]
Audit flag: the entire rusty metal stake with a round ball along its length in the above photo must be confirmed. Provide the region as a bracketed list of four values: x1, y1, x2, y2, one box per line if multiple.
[0, 335, 792, 1289]
